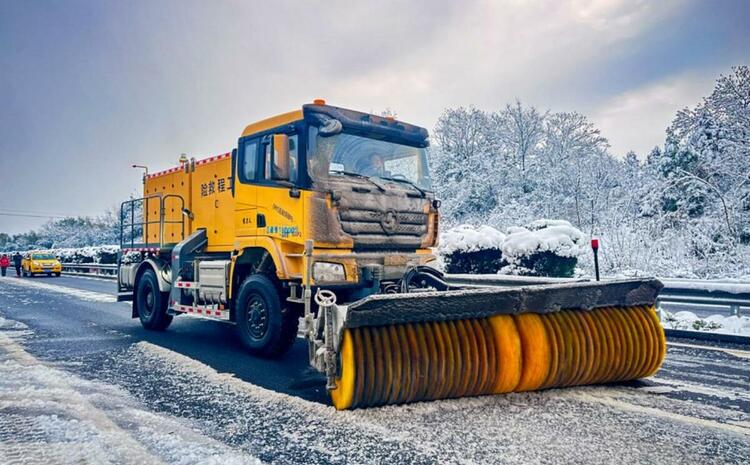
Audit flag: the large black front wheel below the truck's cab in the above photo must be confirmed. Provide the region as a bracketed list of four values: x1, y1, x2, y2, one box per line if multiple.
[235, 274, 299, 358]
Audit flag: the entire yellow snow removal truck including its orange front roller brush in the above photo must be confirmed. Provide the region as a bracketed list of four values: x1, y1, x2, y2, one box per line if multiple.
[118, 100, 665, 409]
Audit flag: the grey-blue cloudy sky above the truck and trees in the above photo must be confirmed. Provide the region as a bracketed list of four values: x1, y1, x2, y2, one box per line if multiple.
[0, 0, 750, 233]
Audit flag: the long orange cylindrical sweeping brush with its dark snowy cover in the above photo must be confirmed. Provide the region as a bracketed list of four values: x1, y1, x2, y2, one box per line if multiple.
[330, 279, 666, 409]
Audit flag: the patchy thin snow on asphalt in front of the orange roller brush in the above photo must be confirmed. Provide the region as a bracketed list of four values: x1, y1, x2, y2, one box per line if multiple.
[120, 342, 750, 463]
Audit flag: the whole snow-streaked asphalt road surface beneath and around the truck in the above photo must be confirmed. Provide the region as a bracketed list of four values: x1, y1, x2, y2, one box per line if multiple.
[0, 276, 750, 464]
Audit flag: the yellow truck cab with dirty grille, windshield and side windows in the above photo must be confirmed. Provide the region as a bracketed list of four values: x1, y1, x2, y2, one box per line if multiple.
[234, 102, 439, 287]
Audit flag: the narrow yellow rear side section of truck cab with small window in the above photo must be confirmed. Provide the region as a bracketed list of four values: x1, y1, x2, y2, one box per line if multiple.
[234, 137, 265, 236]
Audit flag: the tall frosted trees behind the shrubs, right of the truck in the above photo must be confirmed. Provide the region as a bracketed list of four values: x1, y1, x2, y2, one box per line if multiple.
[432, 66, 750, 277]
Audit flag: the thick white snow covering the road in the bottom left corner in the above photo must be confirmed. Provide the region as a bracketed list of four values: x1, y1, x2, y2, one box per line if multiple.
[0, 318, 260, 465]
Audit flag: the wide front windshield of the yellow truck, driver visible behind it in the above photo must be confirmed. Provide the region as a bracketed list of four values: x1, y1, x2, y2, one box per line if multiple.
[307, 127, 432, 190]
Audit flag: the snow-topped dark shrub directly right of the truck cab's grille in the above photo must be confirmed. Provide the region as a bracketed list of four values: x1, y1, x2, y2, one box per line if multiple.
[438, 224, 506, 274]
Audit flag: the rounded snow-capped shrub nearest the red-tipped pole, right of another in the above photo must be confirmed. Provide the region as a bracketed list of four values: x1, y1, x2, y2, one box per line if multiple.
[501, 219, 586, 278]
